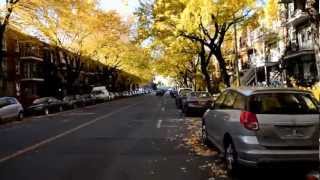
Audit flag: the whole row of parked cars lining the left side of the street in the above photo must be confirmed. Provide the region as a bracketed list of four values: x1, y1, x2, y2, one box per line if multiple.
[0, 87, 151, 123]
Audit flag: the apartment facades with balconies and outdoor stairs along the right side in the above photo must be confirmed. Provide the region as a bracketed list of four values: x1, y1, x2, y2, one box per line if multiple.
[238, 0, 320, 87]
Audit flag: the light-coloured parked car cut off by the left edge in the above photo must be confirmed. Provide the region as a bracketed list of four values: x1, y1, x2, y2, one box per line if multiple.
[0, 97, 23, 123]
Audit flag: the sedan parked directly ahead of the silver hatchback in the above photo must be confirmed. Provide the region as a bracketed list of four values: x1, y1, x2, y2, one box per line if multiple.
[182, 91, 212, 115]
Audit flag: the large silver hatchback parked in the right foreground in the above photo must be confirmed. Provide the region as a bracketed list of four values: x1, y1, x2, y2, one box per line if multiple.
[202, 88, 319, 173]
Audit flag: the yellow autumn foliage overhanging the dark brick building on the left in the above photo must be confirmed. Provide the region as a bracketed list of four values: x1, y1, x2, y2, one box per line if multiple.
[7, 0, 153, 81]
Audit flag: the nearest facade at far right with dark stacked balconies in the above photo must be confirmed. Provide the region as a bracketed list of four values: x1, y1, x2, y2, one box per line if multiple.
[281, 0, 319, 87]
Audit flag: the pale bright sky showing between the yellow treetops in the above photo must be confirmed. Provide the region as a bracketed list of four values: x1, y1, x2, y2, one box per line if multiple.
[0, 0, 139, 18]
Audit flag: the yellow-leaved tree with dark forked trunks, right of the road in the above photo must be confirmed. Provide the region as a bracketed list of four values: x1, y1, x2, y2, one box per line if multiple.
[137, 0, 258, 91]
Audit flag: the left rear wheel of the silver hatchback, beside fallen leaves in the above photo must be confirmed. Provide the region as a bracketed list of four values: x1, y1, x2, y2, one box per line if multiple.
[224, 142, 239, 176]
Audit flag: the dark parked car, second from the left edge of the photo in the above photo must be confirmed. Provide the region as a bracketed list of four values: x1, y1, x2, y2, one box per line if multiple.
[27, 97, 66, 115]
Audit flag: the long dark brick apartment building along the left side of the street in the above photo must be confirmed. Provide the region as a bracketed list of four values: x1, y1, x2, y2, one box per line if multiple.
[0, 28, 137, 105]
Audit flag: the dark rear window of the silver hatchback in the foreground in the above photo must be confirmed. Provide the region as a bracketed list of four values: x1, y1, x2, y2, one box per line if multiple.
[249, 93, 318, 114]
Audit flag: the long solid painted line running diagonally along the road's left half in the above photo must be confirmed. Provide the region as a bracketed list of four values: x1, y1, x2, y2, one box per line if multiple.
[0, 102, 141, 163]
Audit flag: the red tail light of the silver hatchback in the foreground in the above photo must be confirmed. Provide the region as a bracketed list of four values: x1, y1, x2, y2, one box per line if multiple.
[240, 111, 259, 131]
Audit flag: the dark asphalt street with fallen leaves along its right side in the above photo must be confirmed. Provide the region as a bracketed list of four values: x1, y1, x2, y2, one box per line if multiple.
[0, 95, 312, 180]
